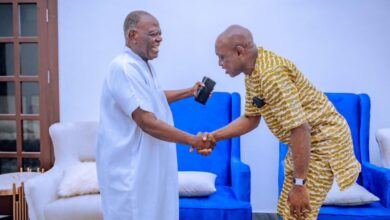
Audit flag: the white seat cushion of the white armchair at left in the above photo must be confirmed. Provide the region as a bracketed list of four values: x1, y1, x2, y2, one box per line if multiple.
[45, 194, 103, 220]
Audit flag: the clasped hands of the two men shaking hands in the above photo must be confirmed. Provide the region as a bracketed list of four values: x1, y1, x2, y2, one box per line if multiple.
[190, 132, 217, 156]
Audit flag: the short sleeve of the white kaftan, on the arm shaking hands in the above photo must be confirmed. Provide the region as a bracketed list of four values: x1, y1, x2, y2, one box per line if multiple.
[108, 59, 152, 117]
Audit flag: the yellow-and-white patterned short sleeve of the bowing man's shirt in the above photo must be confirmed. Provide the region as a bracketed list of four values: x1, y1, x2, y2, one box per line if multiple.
[261, 66, 306, 131]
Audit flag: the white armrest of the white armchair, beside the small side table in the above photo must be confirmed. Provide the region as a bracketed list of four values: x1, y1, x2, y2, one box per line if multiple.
[25, 166, 63, 220]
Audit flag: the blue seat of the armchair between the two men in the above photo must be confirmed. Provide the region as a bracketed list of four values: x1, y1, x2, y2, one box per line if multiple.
[180, 185, 252, 220]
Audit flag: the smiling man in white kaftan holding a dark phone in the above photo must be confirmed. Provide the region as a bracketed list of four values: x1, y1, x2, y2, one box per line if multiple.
[96, 11, 215, 220]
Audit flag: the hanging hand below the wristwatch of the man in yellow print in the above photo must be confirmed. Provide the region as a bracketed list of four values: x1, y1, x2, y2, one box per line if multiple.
[287, 185, 311, 219]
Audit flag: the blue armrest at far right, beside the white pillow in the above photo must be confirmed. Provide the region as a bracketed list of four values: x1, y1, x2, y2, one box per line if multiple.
[362, 163, 390, 208]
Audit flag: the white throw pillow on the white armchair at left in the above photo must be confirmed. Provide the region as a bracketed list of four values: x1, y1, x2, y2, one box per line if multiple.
[58, 162, 99, 197]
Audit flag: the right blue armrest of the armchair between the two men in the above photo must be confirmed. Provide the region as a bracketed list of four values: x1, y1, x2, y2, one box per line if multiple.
[231, 158, 251, 202]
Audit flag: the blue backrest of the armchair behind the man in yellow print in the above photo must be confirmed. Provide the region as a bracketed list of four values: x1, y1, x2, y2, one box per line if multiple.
[279, 93, 370, 188]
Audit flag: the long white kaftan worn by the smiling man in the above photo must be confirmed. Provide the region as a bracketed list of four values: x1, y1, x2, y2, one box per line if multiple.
[96, 49, 179, 220]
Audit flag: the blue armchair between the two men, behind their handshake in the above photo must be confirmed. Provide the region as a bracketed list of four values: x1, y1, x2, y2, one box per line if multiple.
[171, 92, 252, 220]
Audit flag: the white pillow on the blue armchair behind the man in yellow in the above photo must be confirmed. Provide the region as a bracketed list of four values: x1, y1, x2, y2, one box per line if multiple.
[324, 181, 379, 206]
